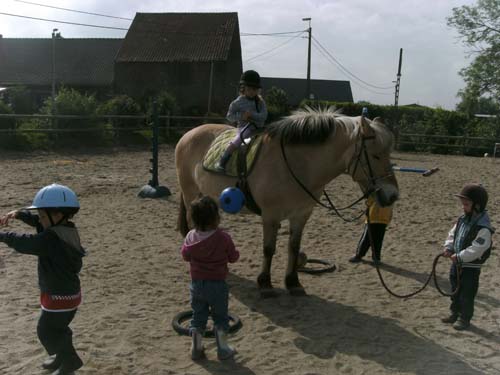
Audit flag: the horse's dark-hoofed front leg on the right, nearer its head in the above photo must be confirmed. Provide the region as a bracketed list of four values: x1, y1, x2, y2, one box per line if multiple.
[285, 213, 311, 296]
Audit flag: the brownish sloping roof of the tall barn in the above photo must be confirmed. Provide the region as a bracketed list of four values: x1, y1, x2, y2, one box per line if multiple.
[116, 13, 239, 62]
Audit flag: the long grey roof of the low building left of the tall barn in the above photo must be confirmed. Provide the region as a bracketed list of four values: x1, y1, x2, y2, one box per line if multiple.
[0, 38, 123, 86]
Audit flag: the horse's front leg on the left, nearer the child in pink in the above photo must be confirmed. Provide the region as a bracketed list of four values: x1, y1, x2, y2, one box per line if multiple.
[257, 220, 280, 298]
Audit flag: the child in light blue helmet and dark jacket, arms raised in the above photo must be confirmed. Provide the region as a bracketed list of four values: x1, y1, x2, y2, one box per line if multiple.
[0, 184, 85, 375]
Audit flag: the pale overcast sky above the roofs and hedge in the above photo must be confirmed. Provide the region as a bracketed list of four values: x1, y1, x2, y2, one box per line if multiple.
[0, 0, 475, 109]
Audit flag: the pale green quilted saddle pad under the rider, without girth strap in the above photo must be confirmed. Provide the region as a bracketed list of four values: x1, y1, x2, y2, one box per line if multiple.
[203, 129, 262, 177]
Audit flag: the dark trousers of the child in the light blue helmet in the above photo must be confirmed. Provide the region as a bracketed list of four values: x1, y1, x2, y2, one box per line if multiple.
[36, 310, 77, 358]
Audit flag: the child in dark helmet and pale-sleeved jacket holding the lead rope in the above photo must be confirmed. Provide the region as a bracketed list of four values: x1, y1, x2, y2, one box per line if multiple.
[441, 184, 494, 331]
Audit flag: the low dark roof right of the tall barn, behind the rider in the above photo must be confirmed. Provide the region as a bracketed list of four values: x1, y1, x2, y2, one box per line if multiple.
[261, 77, 353, 105]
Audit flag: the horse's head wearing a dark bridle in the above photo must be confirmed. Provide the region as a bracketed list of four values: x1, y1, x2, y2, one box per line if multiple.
[347, 116, 399, 206]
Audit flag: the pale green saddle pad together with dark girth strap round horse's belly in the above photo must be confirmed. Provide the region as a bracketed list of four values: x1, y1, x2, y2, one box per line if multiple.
[202, 129, 262, 215]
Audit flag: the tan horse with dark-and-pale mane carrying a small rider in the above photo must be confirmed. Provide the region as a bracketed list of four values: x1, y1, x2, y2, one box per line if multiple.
[175, 108, 399, 297]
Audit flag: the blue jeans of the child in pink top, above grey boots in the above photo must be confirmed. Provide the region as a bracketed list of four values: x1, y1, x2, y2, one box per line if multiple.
[190, 280, 229, 333]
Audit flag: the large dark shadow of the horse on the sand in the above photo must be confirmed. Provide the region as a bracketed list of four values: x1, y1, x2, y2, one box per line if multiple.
[228, 274, 481, 375]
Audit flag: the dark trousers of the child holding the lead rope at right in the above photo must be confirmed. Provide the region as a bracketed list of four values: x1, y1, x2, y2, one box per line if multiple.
[450, 263, 481, 322]
